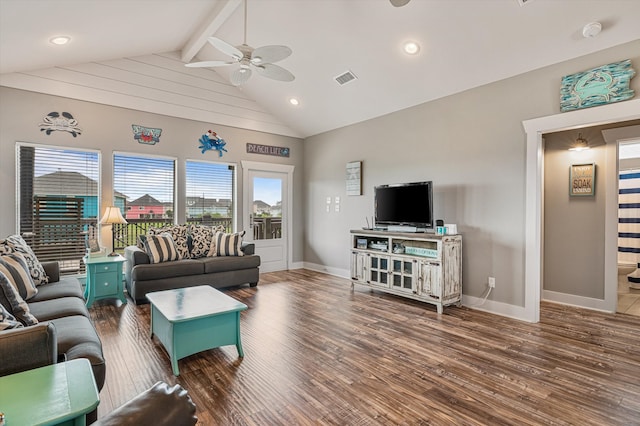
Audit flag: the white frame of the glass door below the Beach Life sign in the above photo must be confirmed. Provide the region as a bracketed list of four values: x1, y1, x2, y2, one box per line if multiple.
[240, 160, 295, 269]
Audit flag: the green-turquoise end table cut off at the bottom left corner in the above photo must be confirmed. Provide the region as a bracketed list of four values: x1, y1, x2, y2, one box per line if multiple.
[0, 358, 100, 426]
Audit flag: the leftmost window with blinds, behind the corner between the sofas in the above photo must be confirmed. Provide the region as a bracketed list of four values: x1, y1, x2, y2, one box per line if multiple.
[17, 144, 100, 273]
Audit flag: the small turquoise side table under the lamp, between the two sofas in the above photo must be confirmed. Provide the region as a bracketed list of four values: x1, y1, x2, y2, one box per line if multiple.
[82, 255, 127, 308]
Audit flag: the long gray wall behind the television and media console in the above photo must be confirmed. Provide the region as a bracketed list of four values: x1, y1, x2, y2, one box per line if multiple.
[304, 41, 640, 306]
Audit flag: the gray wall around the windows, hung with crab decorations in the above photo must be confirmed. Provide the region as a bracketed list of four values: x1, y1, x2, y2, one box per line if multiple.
[0, 87, 304, 262]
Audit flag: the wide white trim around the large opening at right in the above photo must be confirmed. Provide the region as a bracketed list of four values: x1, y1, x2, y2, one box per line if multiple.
[522, 99, 640, 322]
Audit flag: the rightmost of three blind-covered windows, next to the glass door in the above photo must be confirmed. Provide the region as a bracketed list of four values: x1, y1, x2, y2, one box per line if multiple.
[186, 161, 235, 231]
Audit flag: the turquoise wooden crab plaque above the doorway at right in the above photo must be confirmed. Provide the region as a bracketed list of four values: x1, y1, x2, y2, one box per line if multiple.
[560, 59, 636, 112]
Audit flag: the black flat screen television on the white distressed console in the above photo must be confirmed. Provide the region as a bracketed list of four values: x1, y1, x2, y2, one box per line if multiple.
[374, 181, 434, 232]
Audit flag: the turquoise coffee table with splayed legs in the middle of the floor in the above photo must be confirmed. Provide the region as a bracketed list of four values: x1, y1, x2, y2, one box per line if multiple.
[147, 285, 247, 376]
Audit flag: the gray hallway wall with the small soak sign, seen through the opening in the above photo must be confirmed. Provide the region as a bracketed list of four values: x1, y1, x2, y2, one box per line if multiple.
[543, 129, 615, 299]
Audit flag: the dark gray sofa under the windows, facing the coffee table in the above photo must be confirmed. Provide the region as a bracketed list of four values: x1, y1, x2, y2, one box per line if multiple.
[124, 242, 260, 304]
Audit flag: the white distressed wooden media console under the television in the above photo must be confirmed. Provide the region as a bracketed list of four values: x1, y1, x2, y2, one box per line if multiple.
[351, 230, 462, 314]
